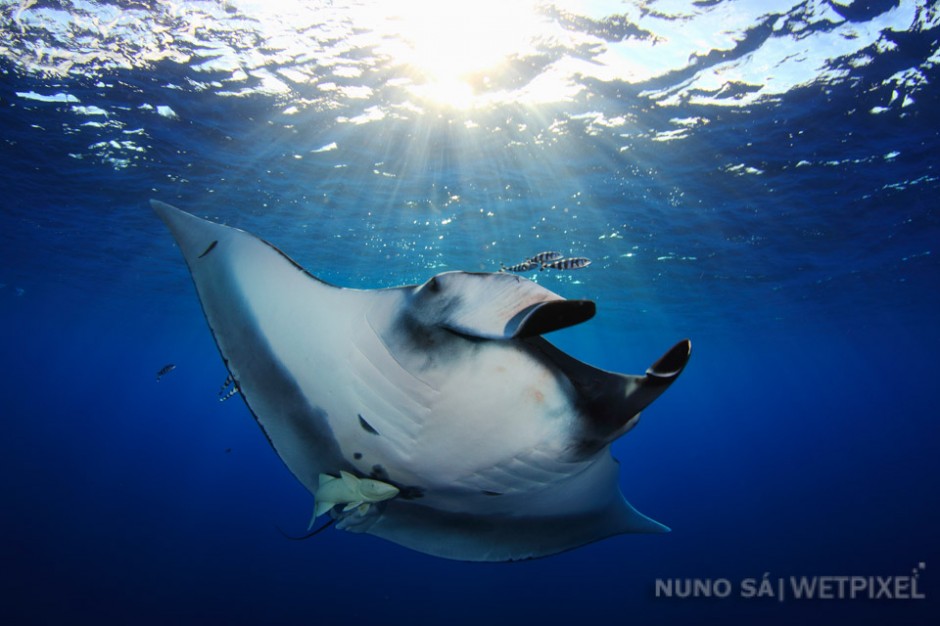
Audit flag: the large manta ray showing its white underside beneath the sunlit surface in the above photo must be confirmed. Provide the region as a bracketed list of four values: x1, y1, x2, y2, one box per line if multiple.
[151, 200, 691, 561]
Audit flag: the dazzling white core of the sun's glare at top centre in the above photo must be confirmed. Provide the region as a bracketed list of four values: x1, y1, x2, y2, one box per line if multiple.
[378, 0, 539, 108]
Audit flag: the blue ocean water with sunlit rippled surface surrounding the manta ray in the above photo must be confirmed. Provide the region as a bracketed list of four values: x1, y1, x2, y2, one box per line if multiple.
[0, 0, 940, 625]
